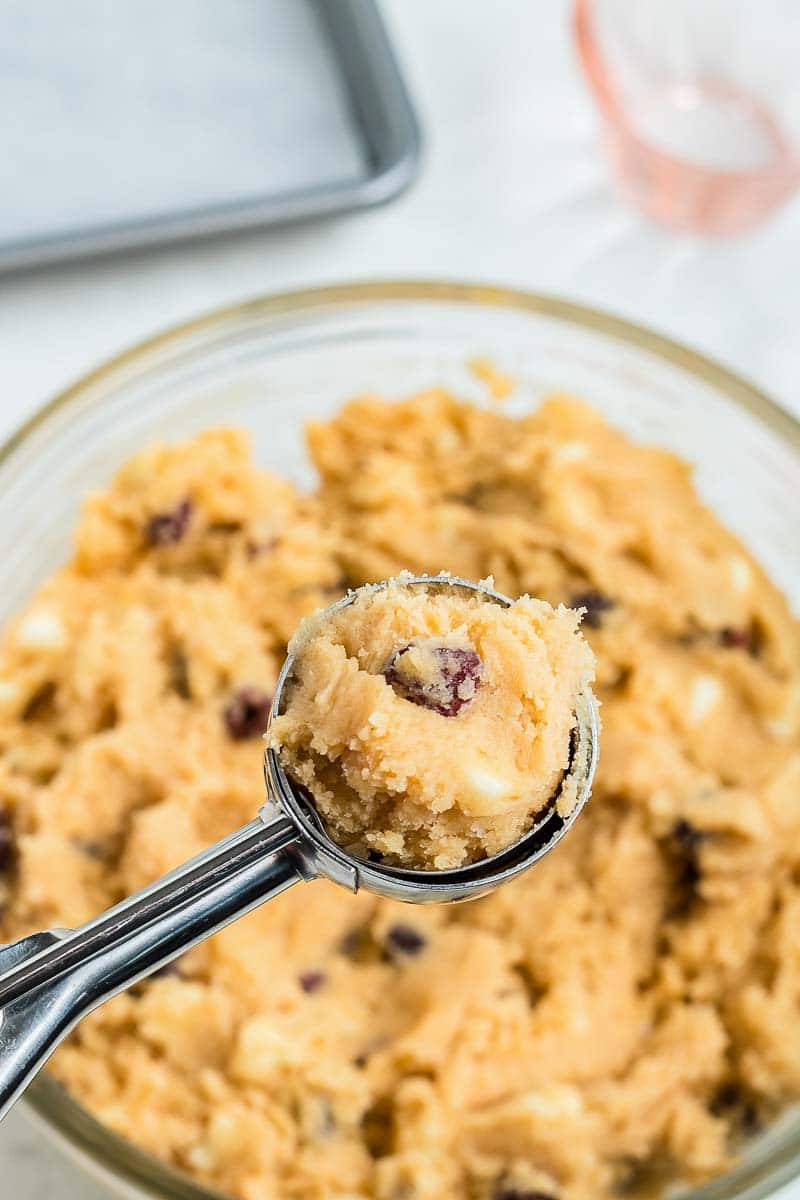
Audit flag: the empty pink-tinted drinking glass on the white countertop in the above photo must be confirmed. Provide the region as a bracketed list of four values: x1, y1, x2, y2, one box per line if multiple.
[575, 0, 800, 234]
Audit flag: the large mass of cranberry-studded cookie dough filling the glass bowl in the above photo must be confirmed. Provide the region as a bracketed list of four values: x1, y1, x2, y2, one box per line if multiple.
[0, 391, 800, 1200]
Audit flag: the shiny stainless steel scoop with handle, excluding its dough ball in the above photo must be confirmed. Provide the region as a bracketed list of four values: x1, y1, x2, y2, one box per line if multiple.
[0, 575, 597, 1118]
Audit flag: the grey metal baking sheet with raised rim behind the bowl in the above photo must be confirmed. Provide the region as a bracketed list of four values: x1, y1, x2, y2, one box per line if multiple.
[0, 0, 420, 270]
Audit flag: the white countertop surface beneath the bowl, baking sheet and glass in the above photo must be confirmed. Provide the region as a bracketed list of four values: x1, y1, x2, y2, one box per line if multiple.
[0, 0, 800, 1200]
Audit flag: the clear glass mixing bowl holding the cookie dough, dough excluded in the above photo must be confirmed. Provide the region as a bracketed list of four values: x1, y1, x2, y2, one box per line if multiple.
[0, 282, 800, 1200]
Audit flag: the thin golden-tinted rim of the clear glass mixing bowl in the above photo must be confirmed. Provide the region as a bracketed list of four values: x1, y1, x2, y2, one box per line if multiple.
[10, 278, 800, 1200]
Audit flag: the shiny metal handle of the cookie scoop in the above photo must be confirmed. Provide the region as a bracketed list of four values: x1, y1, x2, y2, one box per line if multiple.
[0, 814, 303, 1120]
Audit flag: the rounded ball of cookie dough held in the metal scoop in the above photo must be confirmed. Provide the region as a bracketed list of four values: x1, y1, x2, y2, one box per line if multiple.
[270, 575, 593, 871]
